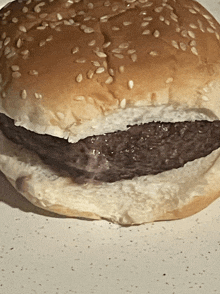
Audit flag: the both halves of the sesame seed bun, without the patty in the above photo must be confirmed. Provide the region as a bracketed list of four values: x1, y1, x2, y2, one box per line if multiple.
[0, 0, 220, 225]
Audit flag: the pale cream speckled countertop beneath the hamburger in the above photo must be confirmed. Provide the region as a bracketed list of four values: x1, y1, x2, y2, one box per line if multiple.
[0, 0, 220, 294]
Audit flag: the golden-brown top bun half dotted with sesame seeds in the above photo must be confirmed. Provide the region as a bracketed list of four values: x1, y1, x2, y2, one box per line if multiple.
[0, 0, 220, 142]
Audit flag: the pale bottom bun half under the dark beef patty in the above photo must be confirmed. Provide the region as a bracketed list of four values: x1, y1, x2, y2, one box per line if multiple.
[0, 132, 220, 225]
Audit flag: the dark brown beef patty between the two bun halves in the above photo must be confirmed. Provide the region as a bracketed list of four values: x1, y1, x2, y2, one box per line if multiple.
[0, 114, 220, 183]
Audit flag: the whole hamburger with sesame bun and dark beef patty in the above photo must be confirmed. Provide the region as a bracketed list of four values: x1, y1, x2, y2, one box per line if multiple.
[0, 0, 220, 225]
